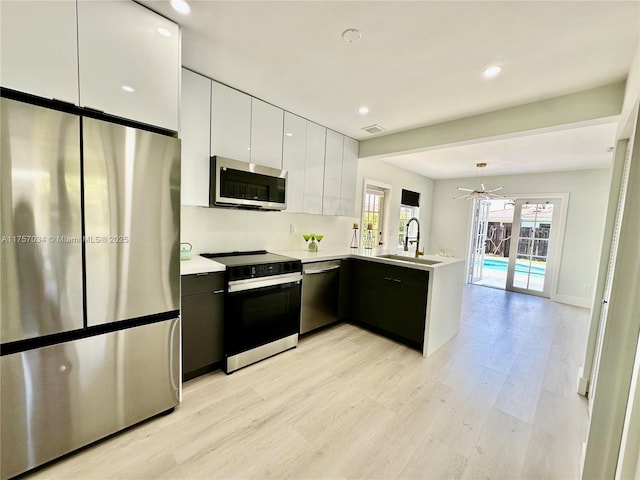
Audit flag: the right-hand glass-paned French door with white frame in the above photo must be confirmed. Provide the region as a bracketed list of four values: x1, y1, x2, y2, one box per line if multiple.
[507, 198, 560, 298]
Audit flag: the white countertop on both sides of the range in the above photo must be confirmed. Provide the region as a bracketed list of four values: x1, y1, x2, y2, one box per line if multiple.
[180, 248, 462, 275]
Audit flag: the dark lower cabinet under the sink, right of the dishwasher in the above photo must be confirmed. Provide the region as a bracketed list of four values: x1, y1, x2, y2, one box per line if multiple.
[349, 260, 429, 350]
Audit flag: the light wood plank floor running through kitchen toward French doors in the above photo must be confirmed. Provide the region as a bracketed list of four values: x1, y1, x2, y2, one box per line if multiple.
[30, 286, 588, 479]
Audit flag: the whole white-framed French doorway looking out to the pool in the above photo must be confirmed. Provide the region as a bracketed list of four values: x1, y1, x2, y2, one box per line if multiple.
[468, 194, 564, 298]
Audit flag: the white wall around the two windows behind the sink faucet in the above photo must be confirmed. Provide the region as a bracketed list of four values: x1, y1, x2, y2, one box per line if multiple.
[356, 158, 434, 251]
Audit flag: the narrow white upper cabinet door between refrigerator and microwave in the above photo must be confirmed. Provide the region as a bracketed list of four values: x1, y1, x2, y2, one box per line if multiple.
[180, 69, 211, 206]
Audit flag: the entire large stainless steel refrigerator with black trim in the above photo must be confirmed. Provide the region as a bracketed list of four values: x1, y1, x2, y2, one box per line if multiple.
[0, 90, 181, 479]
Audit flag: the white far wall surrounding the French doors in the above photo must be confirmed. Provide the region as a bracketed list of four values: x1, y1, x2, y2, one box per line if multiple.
[429, 169, 611, 305]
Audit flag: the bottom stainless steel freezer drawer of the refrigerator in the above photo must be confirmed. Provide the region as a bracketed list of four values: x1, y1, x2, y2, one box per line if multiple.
[0, 319, 181, 479]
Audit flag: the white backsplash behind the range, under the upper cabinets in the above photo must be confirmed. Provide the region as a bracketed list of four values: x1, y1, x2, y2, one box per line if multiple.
[180, 206, 357, 254]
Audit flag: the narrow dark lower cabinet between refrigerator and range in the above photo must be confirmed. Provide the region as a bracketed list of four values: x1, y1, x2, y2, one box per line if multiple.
[181, 272, 224, 381]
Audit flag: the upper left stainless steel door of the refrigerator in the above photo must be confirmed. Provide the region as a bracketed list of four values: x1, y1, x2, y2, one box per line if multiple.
[0, 98, 83, 343]
